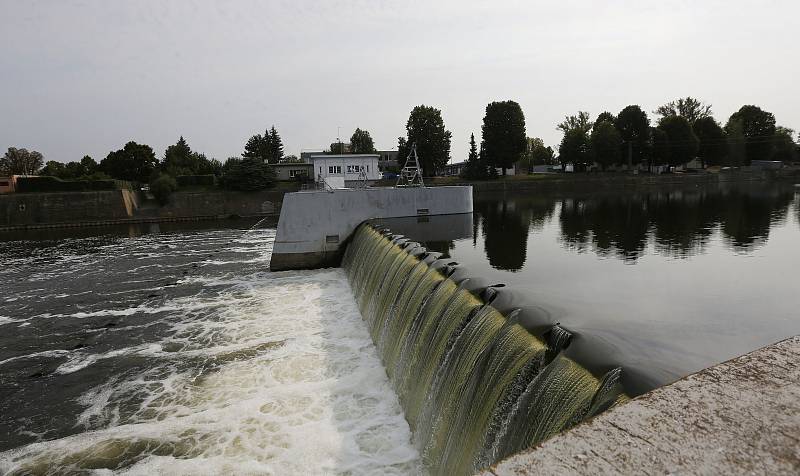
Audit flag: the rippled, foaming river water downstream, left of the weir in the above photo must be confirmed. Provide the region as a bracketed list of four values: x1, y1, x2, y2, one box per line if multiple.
[0, 222, 419, 474]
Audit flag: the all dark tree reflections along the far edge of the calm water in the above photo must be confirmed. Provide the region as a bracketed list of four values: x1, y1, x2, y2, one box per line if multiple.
[476, 184, 794, 271]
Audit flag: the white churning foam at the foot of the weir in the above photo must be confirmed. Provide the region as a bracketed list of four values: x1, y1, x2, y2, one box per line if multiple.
[0, 269, 422, 474]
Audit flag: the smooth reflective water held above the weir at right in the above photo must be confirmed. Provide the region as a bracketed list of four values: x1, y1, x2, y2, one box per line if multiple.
[422, 183, 800, 393]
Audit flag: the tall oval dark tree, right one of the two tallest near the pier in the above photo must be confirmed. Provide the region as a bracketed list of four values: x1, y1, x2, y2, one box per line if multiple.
[482, 101, 527, 175]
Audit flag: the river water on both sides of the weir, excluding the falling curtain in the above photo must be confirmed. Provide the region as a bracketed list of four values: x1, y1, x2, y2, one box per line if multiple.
[0, 184, 800, 474]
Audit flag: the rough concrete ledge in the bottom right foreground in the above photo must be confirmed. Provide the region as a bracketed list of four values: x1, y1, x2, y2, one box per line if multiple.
[482, 336, 800, 476]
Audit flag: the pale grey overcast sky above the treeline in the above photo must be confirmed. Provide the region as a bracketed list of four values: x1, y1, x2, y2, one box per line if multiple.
[0, 0, 800, 162]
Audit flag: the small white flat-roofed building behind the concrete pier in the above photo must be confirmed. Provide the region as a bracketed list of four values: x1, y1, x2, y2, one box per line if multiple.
[308, 154, 381, 188]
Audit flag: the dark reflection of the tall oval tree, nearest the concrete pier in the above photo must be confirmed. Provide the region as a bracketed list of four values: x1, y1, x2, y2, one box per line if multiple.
[473, 197, 555, 271]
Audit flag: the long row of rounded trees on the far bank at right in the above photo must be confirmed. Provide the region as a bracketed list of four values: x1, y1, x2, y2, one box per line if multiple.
[557, 97, 798, 170]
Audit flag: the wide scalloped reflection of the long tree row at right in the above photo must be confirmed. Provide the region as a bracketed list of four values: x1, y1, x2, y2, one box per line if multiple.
[559, 187, 793, 261]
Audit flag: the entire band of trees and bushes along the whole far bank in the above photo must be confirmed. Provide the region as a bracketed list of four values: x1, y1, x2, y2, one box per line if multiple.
[6, 97, 800, 190]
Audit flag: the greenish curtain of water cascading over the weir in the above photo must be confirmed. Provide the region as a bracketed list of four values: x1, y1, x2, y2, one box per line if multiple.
[342, 223, 627, 474]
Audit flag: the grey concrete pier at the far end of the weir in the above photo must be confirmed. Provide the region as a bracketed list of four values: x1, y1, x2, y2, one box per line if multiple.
[270, 186, 472, 271]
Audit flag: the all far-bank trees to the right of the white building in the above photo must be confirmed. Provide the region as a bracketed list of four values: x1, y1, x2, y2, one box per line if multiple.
[388, 97, 800, 179]
